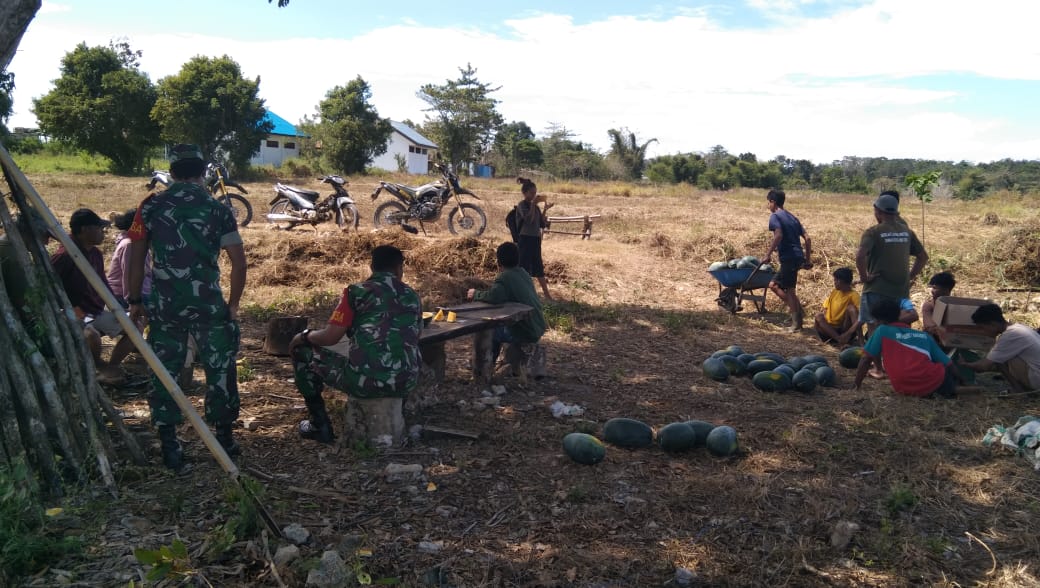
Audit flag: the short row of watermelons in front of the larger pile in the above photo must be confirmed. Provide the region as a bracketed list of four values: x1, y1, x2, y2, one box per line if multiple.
[564, 418, 738, 465]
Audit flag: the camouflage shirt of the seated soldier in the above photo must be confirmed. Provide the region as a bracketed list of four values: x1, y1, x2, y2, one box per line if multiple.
[329, 272, 422, 398]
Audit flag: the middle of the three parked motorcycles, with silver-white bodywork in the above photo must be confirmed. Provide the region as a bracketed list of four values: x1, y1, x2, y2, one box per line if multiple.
[267, 176, 359, 231]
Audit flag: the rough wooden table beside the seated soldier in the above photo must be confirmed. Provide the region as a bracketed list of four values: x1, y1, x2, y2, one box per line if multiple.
[419, 302, 532, 384]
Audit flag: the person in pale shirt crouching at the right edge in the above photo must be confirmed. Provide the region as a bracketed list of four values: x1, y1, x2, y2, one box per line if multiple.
[961, 304, 1040, 392]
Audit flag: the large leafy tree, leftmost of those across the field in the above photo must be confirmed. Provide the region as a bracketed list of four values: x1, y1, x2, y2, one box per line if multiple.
[32, 42, 159, 174]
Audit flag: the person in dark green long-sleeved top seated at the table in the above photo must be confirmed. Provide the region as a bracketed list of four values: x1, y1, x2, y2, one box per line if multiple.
[466, 242, 545, 374]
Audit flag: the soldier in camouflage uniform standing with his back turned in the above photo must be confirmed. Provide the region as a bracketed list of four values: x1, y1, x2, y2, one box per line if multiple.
[127, 145, 245, 470]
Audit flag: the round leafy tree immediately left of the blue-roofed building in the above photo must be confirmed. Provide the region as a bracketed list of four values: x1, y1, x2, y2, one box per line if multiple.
[152, 55, 274, 169]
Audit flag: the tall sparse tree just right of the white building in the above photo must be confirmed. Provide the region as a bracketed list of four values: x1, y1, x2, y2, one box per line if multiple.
[417, 63, 502, 168]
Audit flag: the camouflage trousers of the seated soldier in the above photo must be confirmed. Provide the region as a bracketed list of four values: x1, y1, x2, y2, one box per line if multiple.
[292, 344, 408, 400]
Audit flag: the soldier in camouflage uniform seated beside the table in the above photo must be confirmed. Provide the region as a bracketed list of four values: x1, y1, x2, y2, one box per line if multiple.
[289, 245, 422, 443]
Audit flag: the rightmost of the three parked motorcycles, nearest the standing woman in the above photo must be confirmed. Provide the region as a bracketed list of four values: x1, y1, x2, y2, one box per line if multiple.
[372, 163, 488, 237]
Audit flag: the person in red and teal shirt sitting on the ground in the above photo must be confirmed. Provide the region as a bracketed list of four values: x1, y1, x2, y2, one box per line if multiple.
[856, 298, 960, 398]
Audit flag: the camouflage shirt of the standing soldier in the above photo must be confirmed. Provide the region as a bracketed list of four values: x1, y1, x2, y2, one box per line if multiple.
[127, 182, 242, 322]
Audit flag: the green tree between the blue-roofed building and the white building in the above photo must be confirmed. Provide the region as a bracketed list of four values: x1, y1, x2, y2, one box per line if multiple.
[301, 76, 393, 174]
